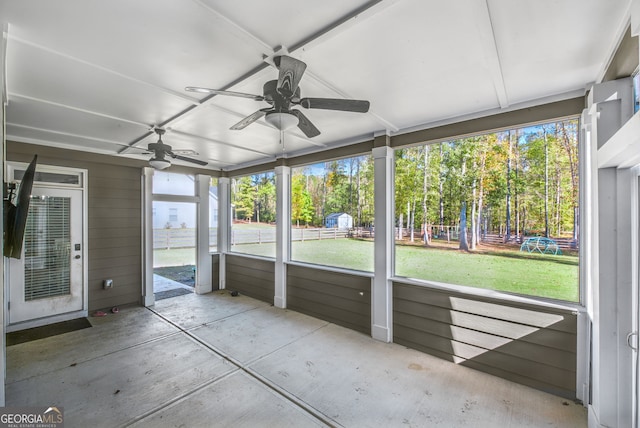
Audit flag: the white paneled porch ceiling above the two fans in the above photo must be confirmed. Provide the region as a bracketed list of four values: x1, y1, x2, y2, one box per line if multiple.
[0, 0, 630, 170]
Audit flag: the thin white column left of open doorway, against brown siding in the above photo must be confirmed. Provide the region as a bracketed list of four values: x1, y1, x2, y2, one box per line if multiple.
[142, 168, 155, 306]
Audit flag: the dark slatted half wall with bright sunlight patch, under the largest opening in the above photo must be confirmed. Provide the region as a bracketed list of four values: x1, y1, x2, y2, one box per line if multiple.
[393, 282, 577, 399]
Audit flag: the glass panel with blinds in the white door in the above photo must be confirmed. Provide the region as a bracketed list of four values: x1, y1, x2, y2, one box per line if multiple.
[24, 196, 71, 301]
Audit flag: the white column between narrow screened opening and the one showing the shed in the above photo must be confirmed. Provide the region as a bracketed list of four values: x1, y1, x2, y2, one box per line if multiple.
[273, 166, 291, 308]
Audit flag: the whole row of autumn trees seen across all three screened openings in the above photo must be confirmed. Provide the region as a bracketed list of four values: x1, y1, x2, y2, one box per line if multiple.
[232, 120, 579, 248]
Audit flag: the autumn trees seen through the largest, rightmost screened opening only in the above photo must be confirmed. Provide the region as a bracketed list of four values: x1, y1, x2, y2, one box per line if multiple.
[395, 120, 579, 249]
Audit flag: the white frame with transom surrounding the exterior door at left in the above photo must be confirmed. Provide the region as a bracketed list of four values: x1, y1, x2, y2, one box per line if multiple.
[4, 161, 89, 332]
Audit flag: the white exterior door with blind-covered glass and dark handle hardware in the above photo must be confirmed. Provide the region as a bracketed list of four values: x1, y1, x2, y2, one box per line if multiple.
[9, 186, 85, 325]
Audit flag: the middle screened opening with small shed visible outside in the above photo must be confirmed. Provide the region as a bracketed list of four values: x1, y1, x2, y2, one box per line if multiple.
[291, 156, 374, 272]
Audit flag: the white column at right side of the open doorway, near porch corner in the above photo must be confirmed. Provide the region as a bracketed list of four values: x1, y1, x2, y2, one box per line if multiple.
[195, 174, 213, 294]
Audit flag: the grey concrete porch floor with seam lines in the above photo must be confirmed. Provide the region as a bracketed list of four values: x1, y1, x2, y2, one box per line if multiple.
[6, 291, 587, 428]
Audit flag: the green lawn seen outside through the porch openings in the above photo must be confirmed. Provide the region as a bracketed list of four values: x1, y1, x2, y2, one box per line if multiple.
[154, 239, 579, 302]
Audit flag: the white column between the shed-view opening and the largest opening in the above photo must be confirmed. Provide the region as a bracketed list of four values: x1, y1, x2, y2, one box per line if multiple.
[371, 142, 394, 342]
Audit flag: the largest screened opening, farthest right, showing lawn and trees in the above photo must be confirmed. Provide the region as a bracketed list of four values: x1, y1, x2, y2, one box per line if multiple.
[395, 120, 580, 302]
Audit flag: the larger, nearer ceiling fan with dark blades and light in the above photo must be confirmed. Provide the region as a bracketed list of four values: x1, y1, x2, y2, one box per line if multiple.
[185, 55, 369, 138]
